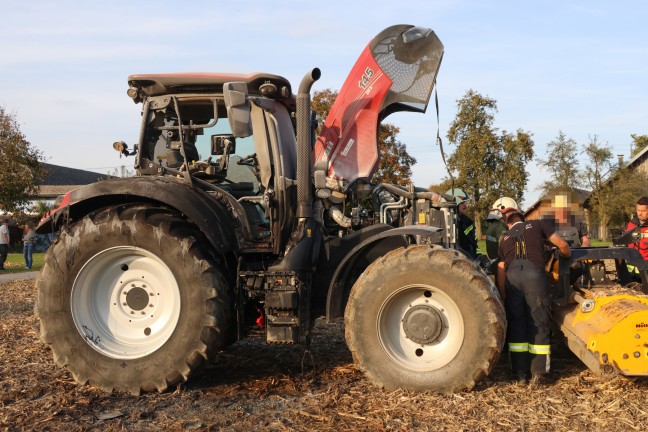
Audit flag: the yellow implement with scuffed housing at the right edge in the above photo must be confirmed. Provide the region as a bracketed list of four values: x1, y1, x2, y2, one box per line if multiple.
[553, 288, 648, 376]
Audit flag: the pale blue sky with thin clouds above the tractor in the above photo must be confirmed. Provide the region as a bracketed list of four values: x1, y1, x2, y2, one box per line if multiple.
[0, 0, 648, 205]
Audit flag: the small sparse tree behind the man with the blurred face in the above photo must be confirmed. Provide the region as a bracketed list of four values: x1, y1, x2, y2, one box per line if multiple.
[538, 131, 582, 193]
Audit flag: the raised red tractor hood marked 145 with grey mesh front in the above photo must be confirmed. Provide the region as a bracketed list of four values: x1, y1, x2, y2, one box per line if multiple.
[314, 25, 443, 191]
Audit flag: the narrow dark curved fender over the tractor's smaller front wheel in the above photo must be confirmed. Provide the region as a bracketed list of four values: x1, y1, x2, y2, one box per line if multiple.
[326, 225, 441, 322]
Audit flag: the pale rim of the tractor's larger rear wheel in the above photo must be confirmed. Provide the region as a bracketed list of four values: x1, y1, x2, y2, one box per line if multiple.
[71, 246, 181, 359]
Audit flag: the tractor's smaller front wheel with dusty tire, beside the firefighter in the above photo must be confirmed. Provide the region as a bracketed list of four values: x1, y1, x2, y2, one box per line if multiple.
[345, 246, 506, 393]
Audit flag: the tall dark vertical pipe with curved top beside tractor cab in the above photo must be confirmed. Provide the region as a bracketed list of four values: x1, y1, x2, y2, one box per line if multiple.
[296, 68, 321, 218]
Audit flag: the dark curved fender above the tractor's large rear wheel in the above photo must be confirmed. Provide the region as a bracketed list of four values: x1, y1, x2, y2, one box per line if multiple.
[36, 177, 250, 255]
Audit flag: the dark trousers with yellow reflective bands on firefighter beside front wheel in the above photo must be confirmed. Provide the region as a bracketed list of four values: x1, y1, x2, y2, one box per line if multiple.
[506, 260, 551, 374]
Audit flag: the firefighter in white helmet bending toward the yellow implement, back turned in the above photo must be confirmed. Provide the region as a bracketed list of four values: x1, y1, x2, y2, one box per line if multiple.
[496, 207, 571, 385]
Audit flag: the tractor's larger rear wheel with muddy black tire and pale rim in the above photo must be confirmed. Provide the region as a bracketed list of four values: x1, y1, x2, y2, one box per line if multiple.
[36, 205, 231, 394]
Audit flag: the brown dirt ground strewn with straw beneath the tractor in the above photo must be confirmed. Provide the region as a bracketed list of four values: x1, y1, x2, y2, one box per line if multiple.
[0, 280, 648, 432]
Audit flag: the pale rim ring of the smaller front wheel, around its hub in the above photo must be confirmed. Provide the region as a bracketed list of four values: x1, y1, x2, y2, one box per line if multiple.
[377, 285, 464, 372]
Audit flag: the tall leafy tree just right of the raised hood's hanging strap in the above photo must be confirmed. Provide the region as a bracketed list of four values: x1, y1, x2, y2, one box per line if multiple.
[442, 89, 533, 232]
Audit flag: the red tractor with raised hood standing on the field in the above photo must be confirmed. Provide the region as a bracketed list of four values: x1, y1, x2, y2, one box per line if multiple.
[36, 25, 506, 394]
